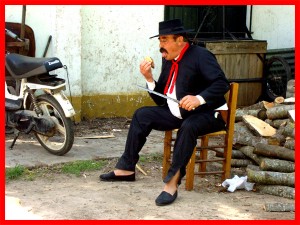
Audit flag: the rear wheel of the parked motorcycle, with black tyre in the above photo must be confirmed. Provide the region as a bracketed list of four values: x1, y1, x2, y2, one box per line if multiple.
[30, 95, 74, 155]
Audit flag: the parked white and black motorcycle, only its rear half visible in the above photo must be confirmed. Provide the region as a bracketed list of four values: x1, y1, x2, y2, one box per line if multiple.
[5, 28, 75, 155]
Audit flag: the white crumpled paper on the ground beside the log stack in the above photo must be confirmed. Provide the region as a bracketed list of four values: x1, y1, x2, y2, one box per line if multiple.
[222, 175, 254, 192]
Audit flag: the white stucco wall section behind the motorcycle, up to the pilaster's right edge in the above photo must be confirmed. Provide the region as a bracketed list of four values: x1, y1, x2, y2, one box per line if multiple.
[5, 5, 82, 96]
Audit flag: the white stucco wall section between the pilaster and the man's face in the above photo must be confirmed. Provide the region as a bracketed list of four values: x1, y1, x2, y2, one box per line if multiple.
[81, 6, 163, 94]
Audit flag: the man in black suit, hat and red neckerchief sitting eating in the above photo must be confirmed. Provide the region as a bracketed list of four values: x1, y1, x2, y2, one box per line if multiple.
[100, 19, 230, 206]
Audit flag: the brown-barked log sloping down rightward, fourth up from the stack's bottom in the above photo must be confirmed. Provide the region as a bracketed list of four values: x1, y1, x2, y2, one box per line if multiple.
[253, 143, 295, 161]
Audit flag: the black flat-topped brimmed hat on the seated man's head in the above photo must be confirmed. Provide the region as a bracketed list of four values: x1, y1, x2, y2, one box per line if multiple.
[150, 19, 193, 38]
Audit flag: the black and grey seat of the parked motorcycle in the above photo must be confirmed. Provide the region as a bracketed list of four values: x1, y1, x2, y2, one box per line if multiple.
[5, 53, 63, 79]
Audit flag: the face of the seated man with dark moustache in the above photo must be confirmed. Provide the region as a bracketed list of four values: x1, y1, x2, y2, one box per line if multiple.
[158, 35, 183, 60]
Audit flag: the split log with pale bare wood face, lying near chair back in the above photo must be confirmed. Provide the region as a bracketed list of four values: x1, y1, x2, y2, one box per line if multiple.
[242, 115, 276, 137]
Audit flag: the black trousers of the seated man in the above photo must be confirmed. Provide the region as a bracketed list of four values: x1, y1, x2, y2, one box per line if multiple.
[116, 106, 225, 184]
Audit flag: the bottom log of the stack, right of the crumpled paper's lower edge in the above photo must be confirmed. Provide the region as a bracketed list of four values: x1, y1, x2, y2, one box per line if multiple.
[255, 184, 295, 199]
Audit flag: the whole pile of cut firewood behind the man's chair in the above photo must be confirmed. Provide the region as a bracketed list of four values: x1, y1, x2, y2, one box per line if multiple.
[232, 83, 295, 199]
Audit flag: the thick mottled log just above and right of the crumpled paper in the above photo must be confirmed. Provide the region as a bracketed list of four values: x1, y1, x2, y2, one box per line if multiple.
[247, 169, 295, 187]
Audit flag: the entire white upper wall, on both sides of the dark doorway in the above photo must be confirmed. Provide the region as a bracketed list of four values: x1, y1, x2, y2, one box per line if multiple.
[5, 5, 295, 96]
